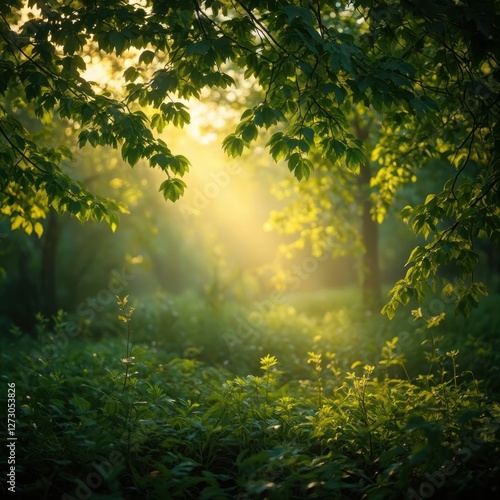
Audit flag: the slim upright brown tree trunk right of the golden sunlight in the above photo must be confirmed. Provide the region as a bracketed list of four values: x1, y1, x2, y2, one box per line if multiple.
[359, 165, 382, 310]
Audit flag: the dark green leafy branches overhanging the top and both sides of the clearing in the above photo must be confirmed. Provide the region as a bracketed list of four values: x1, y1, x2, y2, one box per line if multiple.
[0, 0, 500, 316]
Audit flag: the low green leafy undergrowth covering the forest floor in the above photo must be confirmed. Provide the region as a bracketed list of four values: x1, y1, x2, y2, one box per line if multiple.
[2, 299, 500, 499]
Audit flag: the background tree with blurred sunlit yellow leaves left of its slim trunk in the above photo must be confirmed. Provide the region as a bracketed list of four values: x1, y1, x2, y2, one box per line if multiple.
[270, 114, 382, 310]
